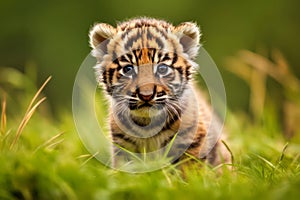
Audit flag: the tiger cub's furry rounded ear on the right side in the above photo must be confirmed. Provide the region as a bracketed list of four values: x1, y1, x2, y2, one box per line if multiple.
[174, 22, 201, 60]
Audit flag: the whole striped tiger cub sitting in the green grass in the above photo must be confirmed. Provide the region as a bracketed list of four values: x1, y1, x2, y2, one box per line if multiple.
[89, 18, 230, 170]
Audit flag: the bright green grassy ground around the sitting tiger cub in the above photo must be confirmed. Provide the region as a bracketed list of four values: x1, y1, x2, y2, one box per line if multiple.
[0, 69, 300, 200]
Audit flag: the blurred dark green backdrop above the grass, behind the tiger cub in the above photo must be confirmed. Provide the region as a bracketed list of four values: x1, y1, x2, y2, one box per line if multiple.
[0, 0, 300, 111]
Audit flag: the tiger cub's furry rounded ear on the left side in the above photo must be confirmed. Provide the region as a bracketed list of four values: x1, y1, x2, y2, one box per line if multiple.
[89, 23, 116, 50]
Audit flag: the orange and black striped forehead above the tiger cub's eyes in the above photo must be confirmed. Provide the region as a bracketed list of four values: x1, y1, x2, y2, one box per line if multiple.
[108, 27, 182, 64]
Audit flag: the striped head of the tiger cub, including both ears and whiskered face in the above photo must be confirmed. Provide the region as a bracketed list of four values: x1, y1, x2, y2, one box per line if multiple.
[90, 18, 200, 128]
